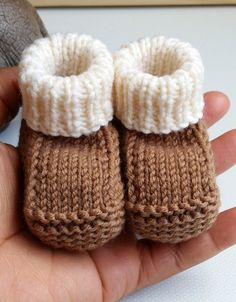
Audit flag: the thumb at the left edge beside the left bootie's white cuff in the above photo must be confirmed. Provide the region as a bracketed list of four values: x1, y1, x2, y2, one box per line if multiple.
[0, 67, 20, 127]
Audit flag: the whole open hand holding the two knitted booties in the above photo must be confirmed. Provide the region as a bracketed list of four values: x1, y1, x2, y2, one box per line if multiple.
[0, 68, 236, 302]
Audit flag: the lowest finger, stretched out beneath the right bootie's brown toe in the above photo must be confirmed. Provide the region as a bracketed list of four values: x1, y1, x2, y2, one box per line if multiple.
[138, 208, 236, 288]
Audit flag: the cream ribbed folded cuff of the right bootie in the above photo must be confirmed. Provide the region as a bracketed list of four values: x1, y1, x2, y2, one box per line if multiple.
[113, 36, 204, 134]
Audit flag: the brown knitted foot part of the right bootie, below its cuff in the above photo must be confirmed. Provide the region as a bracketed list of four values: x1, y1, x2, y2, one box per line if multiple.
[123, 122, 220, 243]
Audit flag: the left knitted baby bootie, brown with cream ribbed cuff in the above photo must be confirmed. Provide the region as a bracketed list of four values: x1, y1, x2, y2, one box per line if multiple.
[19, 34, 124, 251]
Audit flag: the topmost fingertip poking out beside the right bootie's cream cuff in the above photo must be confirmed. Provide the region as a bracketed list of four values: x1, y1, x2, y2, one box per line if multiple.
[203, 91, 230, 127]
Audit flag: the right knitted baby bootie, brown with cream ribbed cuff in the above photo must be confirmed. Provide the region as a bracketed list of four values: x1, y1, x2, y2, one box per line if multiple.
[114, 37, 220, 243]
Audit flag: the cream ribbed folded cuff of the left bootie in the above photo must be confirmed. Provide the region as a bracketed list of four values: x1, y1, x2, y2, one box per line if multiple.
[19, 34, 114, 137]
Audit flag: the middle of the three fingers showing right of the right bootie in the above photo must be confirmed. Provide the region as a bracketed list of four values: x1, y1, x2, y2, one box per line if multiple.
[211, 129, 236, 175]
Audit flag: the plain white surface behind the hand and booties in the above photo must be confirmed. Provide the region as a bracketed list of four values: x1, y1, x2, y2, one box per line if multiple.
[0, 7, 236, 302]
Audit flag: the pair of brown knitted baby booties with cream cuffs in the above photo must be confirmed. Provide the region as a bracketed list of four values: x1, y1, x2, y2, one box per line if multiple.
[19, 34, 220, 251]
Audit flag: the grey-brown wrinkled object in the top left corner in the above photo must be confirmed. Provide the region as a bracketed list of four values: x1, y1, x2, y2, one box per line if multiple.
[0, 0, 47, 67]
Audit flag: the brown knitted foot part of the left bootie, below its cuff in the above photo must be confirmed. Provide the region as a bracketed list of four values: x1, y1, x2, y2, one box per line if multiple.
[19, 120, 124, 251]
